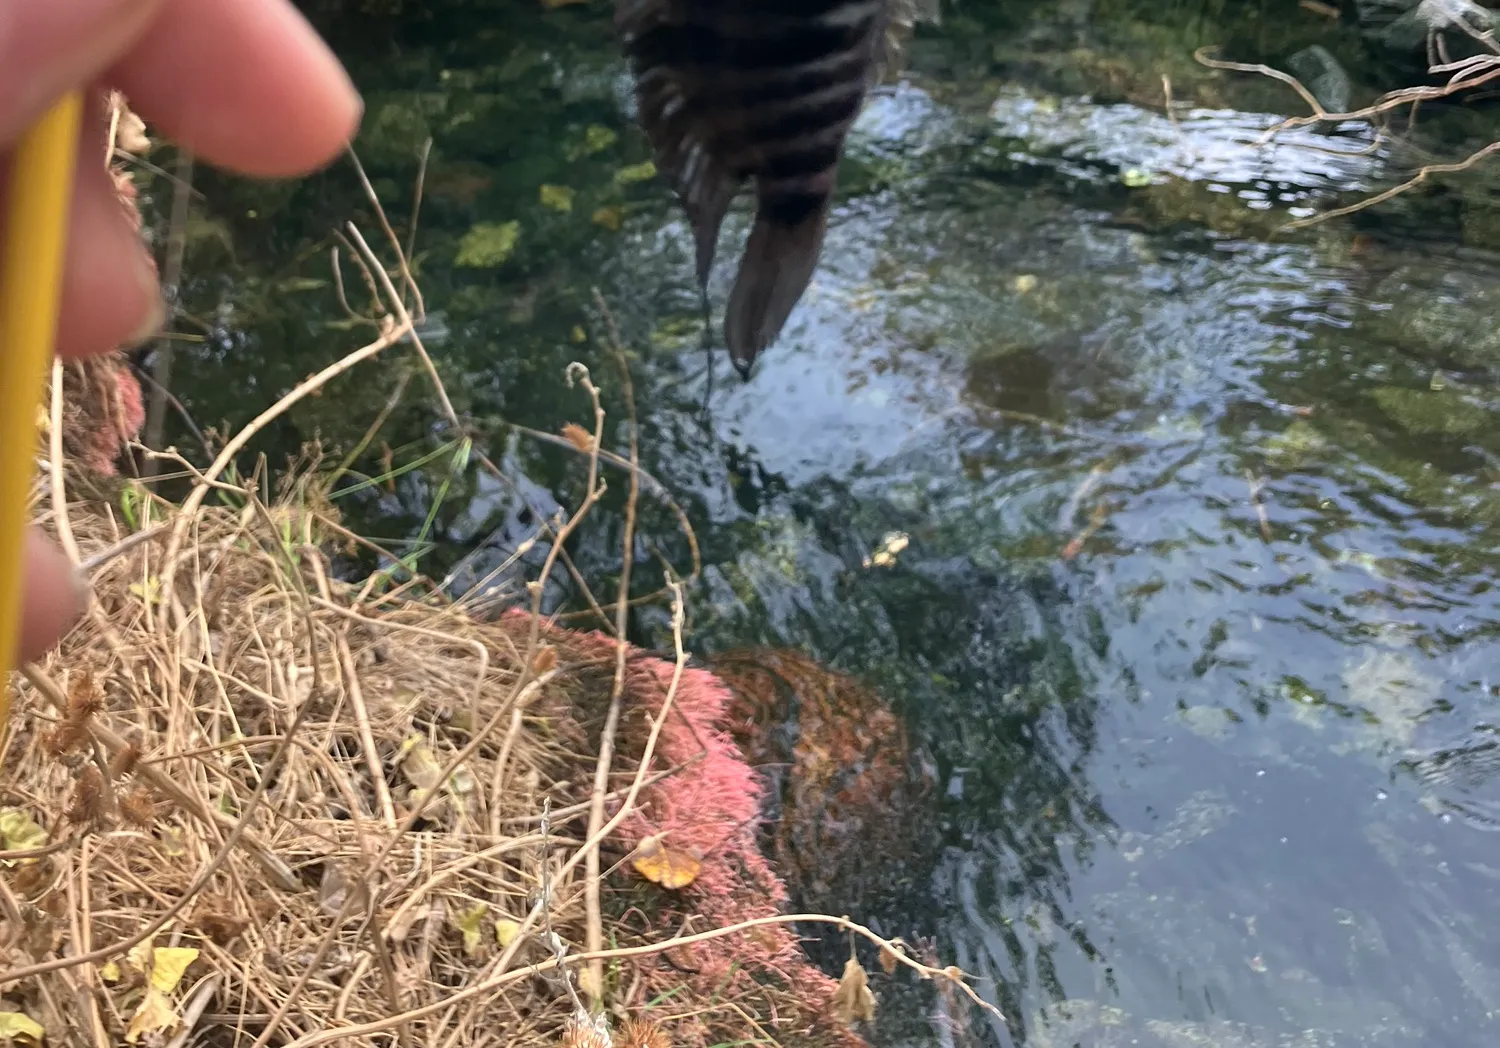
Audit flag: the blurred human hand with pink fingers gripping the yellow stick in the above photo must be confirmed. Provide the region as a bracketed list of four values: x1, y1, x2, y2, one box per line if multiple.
[0, 0, 362, 660]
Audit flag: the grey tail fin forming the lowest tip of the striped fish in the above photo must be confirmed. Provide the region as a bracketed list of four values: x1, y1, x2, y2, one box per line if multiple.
[725, 198, 828, 379]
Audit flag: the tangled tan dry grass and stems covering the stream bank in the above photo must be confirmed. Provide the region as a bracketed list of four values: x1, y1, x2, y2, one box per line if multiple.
[0, 122, 993, 1048]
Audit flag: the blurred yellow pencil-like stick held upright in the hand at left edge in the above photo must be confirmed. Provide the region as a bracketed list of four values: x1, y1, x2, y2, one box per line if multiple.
[0, 93, 83, 736]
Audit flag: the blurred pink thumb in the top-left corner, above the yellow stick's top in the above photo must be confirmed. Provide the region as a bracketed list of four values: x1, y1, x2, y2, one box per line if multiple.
[0, 0, 162, 147]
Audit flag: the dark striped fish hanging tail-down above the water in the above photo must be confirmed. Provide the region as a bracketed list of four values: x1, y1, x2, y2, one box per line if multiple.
[615, 0, 938, 378]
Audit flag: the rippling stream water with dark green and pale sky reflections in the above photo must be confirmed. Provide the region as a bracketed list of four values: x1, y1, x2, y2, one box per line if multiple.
[155, 4, 1500, 1048]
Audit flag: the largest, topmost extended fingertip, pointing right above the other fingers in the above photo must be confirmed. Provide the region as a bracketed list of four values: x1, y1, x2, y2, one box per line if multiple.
[110, 0, 362, 177]
